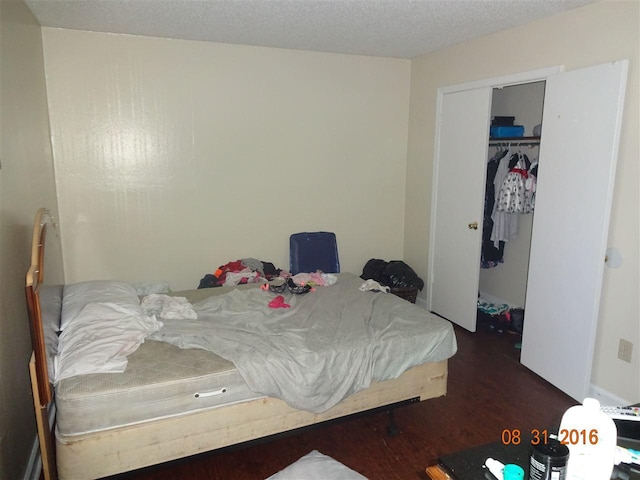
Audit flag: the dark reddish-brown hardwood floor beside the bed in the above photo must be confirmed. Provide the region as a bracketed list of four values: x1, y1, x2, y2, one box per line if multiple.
[114, 328, 577, 480]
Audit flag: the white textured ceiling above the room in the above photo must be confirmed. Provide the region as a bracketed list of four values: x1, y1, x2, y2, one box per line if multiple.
[25, 0, 594, 58]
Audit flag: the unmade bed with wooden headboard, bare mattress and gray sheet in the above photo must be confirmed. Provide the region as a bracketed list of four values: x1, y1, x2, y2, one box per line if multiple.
[26, 209, 456, 480]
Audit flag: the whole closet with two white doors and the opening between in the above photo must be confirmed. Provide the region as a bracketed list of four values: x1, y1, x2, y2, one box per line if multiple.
[426, 60, 628, 401]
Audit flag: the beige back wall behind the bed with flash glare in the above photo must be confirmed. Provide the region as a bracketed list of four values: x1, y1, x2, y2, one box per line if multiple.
[43, 28, 411, 289]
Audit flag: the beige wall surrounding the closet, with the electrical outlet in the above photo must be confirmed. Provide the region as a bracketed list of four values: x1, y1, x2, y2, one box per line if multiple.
[404, 1, 640, 402]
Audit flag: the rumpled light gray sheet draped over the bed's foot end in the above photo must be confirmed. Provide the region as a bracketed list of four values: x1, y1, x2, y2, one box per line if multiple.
[149, 273, 456, 413]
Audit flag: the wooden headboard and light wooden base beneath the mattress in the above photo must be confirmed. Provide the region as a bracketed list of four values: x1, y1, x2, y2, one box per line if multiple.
[26, 209, 447, 480]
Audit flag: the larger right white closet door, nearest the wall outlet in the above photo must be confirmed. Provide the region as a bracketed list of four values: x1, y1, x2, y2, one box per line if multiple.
[521, 61, 627, 401]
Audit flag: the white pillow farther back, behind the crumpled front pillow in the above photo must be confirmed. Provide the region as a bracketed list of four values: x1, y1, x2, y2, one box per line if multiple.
[60, 280, 142, 330]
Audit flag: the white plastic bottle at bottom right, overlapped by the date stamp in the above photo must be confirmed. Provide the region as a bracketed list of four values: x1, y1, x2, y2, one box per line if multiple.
[558, 398, 618, 480]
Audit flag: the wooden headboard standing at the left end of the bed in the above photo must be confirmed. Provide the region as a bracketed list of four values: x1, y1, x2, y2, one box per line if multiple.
[25, 208, 58, 480]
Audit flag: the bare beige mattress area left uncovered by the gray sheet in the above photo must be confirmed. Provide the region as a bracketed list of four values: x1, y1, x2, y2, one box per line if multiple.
[55, 285, 263, 437]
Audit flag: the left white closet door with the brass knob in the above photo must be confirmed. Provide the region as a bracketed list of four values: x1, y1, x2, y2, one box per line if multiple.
[429, 88, 492, 332]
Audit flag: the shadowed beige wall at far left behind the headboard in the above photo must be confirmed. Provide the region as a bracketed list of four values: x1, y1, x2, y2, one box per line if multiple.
[0, 0, 62, 480]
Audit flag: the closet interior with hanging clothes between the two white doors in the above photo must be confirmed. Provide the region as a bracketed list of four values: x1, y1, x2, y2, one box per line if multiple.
[478, 81, 545, 314]
